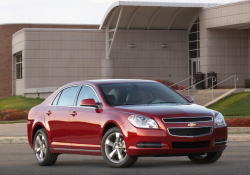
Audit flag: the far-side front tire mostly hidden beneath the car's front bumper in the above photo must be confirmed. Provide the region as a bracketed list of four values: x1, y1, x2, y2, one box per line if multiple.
[188, 152, 222, 164]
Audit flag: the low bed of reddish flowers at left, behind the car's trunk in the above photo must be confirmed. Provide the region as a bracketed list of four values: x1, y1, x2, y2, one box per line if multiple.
[0, 109, 29, 121]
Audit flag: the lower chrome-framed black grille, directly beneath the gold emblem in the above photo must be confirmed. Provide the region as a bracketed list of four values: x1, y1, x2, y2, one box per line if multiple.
[168, 127, 213, 137]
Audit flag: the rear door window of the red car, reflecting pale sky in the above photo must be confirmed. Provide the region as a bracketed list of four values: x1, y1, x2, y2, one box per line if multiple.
[58, 86, 79, 106]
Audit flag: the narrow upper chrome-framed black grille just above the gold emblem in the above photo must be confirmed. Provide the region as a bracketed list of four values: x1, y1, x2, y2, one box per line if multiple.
[162, 117, 213, 123]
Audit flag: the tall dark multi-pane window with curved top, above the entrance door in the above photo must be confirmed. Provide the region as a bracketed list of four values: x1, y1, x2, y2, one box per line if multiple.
[189, 18, 200, 58]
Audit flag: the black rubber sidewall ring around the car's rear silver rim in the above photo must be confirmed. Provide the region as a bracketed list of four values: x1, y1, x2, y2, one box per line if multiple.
[33, 129, 50, 165]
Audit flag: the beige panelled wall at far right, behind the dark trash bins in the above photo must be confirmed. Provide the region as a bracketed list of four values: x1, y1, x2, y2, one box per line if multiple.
[201, 29, 249, 88]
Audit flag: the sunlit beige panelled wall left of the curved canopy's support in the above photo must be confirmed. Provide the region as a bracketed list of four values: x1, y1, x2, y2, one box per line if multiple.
[15, 29, 105, 89]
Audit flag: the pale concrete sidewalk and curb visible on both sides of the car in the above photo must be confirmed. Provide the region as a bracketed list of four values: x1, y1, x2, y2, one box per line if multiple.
[0, 123, 250, 143]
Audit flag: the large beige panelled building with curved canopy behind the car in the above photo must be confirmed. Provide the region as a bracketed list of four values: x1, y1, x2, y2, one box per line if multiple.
[4, 1, 250, 98]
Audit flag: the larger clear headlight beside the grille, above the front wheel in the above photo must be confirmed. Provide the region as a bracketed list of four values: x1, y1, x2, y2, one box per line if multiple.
[128, 115, 159, 129]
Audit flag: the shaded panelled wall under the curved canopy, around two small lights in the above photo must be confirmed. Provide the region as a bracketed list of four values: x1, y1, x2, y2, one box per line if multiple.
[111, 30, 188, 85]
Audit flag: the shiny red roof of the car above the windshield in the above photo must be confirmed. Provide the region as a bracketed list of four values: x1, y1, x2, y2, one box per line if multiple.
[70, 79, 155, 84]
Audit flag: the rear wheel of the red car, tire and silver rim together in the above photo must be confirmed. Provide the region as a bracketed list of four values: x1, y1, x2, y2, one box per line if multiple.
[33, 129, 58, 166]
